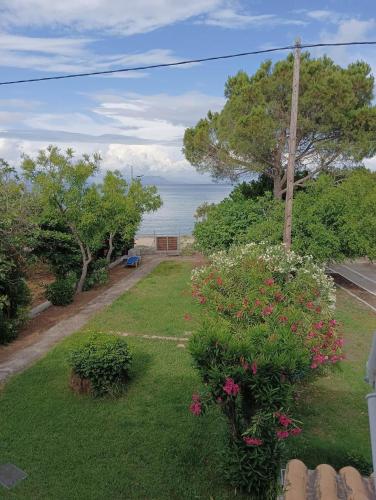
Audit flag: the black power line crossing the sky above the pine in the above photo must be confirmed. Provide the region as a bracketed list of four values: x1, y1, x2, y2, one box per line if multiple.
[0, 42, 376, 85]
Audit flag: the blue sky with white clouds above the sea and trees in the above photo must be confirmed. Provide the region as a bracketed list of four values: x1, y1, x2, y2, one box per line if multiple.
[0, 0, 376, 183]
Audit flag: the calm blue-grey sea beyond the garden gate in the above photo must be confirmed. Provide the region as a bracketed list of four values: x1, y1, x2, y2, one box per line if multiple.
[138, 184, 232, 236]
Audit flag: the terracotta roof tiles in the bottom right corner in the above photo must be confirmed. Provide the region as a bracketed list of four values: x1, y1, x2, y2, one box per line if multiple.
[283, 459, 376, 500]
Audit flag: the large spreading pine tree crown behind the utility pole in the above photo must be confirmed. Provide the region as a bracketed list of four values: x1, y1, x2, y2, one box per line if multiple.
[183, 53, 376, 199]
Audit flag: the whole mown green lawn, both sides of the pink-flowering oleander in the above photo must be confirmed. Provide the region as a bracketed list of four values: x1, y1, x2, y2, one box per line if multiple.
[0, 261, 376, 500]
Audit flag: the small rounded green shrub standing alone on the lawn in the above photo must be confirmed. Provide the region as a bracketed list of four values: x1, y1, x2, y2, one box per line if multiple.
[70, 333, 132, 396]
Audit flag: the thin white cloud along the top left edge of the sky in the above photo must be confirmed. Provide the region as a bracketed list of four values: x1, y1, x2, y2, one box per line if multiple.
[0, 0, 223, 35]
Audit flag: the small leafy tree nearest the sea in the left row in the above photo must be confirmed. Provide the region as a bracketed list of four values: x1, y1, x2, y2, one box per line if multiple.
[99, 171, 162, 262]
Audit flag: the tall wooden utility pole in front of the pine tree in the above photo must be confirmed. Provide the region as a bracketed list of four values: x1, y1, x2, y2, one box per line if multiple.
[283, 38, 301, 250]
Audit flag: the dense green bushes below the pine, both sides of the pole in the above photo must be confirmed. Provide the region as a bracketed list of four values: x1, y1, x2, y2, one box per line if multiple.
[194, 168, 376, 262]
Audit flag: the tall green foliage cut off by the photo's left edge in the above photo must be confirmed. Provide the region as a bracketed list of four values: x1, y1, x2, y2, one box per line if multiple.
[0, 161, 33, 343]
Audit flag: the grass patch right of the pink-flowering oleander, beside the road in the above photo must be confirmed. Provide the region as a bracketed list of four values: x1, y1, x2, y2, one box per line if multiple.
[286, 290, 376, 468]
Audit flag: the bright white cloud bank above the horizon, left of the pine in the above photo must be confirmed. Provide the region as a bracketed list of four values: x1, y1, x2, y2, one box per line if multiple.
[0, 92, 224, 182]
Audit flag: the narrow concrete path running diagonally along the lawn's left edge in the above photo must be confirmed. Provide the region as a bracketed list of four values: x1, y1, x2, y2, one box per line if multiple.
[0, 256, 166, 382]
